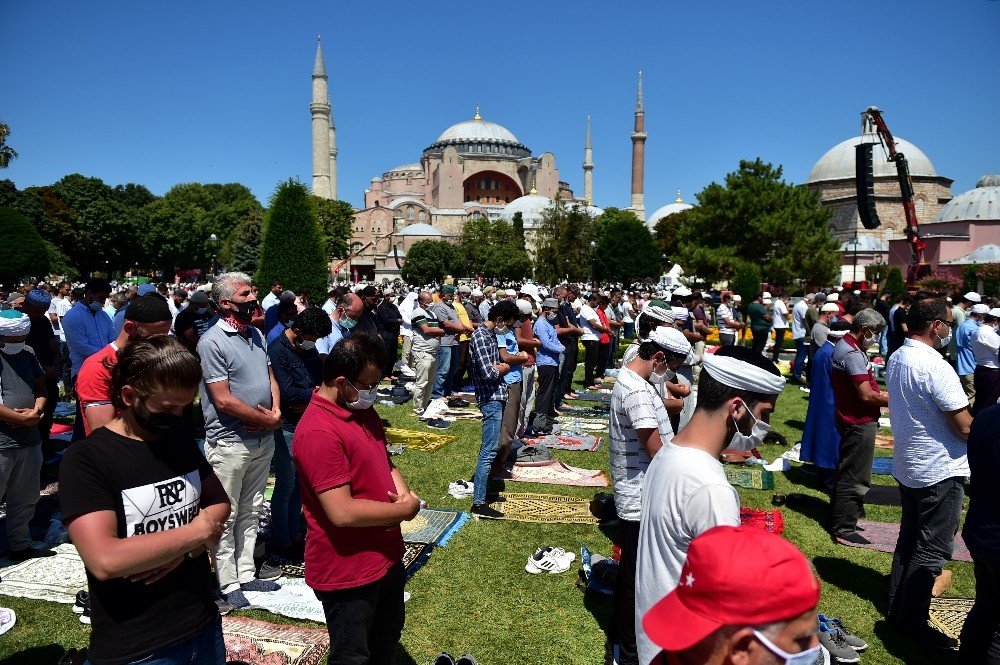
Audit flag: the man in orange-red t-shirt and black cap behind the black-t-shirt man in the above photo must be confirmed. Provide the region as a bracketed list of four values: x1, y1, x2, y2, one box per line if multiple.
[76, 293, 173, 436]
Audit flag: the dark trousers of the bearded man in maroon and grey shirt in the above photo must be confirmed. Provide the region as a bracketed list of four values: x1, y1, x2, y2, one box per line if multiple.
[830, 423, 878, 536]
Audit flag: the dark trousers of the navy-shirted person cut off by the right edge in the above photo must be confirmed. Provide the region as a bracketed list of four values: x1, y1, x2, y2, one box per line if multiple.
[958, 550, 1000, 665]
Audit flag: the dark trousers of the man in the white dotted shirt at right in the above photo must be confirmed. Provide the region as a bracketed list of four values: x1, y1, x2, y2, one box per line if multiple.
[888, 477, 965, 632]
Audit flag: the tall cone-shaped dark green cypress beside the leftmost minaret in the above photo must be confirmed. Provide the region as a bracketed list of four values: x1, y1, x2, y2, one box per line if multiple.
[257, 179, 329, 294]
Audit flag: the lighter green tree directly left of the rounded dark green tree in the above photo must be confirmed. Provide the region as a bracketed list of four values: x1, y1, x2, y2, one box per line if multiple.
[535, 199, 594, 284]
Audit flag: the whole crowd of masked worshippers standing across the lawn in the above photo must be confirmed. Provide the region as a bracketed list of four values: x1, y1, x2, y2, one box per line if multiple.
[0, 272, 1000, 665]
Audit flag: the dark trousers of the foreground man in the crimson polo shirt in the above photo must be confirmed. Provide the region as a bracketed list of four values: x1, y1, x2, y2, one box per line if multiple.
[315, 562, 406, 665]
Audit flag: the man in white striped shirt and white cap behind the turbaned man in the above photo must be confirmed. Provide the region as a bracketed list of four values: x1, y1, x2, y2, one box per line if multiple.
[608, 328, 691, 665]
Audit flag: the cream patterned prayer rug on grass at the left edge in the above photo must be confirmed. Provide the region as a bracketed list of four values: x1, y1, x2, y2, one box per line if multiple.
[0, 543, 87, 605]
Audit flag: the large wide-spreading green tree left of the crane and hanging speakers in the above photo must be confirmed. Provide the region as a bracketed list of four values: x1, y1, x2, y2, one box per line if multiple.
[677, 158, 840, 285]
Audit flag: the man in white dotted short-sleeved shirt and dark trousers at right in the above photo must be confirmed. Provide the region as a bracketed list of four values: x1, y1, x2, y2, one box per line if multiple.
[886, 300, 972, 648]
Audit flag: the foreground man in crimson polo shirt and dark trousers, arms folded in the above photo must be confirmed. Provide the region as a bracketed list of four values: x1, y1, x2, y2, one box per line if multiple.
[292, 331, 420, 665]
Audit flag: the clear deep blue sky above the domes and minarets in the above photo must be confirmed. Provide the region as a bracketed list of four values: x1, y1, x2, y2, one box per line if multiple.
[0, 0, 1000, 211]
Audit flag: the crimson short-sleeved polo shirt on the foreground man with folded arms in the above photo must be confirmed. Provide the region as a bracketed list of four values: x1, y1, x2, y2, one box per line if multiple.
[292, 393, 404, 591]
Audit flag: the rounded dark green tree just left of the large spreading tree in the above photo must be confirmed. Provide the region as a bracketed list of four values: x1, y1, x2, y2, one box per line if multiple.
[594, 208, 663, 283]
